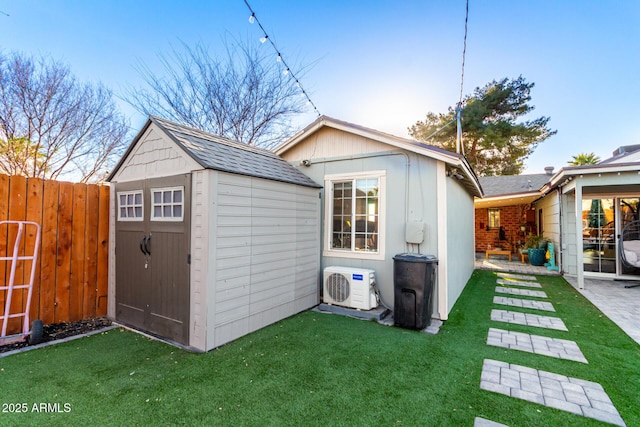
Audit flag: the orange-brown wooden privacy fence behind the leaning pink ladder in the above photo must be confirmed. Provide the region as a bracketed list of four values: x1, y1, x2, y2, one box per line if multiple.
[0, 175, 109, 333]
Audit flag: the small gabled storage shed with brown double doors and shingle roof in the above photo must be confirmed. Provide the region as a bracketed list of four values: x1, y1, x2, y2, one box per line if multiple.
[108, 116, 321, 351]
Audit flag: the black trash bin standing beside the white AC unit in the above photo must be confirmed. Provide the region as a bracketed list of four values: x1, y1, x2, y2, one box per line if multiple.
[393, 254, 438, 330]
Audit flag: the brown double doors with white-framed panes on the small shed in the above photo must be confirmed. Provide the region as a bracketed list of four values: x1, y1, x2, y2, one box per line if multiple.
[116, 174, 191, 344]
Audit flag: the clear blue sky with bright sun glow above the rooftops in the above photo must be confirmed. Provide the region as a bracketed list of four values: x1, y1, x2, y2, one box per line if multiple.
[0, 0, 640, 173]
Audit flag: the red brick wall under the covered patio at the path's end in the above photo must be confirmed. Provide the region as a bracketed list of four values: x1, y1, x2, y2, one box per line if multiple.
[475, 204, 537, 252]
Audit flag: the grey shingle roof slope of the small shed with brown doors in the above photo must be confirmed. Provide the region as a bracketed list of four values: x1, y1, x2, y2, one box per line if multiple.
[149, 116, 321, 188]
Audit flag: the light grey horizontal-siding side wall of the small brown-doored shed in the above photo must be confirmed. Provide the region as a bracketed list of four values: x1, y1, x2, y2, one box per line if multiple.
[192, 171, 320, 350]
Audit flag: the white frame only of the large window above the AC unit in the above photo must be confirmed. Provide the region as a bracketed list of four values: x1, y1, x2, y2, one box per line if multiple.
[322, 170, 387, 260]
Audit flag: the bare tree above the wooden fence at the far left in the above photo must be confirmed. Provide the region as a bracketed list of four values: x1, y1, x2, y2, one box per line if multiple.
[0, 53, 129, 182]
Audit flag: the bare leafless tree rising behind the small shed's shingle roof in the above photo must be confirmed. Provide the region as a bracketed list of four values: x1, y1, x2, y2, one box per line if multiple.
[125, 40, 305, 148]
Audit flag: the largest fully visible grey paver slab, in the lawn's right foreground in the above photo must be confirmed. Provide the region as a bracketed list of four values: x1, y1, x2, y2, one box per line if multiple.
[480, 359, 626, 426]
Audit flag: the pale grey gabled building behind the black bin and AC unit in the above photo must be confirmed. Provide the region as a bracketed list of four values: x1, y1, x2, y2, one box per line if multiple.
[275, 116, 482, 320]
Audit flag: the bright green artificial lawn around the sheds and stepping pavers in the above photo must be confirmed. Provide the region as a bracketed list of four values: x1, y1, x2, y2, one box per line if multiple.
[0, 271, 640, 427]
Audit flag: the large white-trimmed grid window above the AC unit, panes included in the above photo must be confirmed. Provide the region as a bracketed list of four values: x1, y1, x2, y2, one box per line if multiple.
[325, 171, 385, 256]
